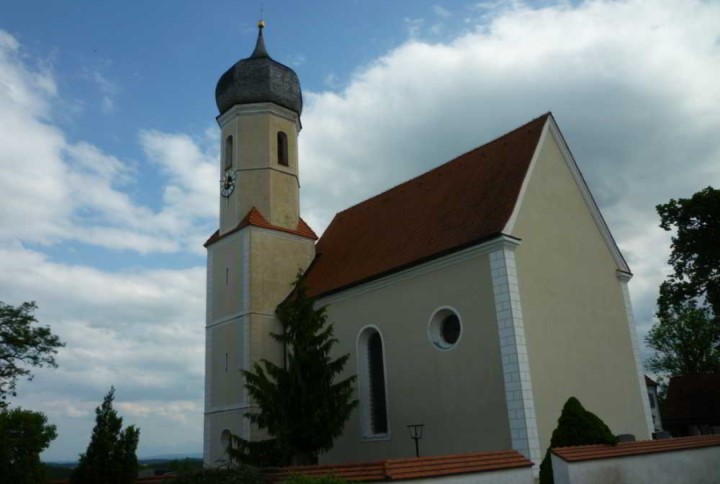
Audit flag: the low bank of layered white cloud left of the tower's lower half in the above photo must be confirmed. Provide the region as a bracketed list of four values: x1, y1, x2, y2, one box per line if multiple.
[5, 246, 205, 459]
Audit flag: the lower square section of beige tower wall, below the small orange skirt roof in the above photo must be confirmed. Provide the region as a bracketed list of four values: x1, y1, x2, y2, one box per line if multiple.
[205, 227, 315, 464]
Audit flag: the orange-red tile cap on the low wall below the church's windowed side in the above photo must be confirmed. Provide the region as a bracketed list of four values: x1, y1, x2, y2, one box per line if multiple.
[268, 450, 533, 481]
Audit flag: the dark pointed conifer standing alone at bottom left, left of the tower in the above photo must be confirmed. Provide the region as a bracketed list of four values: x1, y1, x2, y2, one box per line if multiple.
[71, 387, 140, 484]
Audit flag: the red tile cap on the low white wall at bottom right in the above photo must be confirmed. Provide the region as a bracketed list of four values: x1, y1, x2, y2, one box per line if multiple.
[552, 435, 720, 462]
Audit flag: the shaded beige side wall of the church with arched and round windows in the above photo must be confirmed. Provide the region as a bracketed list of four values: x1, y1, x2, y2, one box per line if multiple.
[319, 254, 510, 463]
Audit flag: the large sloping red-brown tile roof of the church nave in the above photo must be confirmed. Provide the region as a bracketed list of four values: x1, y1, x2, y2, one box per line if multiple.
[306, 113, 551, 296]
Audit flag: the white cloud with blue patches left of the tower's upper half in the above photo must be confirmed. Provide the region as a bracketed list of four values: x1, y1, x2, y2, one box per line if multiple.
[0, 32, 217, 254]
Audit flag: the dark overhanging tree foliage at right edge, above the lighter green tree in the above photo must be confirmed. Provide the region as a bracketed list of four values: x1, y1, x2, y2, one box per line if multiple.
[656, 187, 720, 323]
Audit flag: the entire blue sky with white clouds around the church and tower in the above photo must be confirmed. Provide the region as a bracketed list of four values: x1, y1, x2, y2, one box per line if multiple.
[0, 0, 720, 461]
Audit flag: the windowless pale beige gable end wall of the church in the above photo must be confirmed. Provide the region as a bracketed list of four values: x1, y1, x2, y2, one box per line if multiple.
[512, 133, 649, 458]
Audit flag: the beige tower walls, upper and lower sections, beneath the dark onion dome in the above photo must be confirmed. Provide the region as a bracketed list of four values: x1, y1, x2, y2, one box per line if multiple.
[204, 103, 315, 466]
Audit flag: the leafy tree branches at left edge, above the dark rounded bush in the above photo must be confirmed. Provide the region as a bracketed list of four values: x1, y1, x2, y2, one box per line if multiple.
[0, 301, 65, 407]
